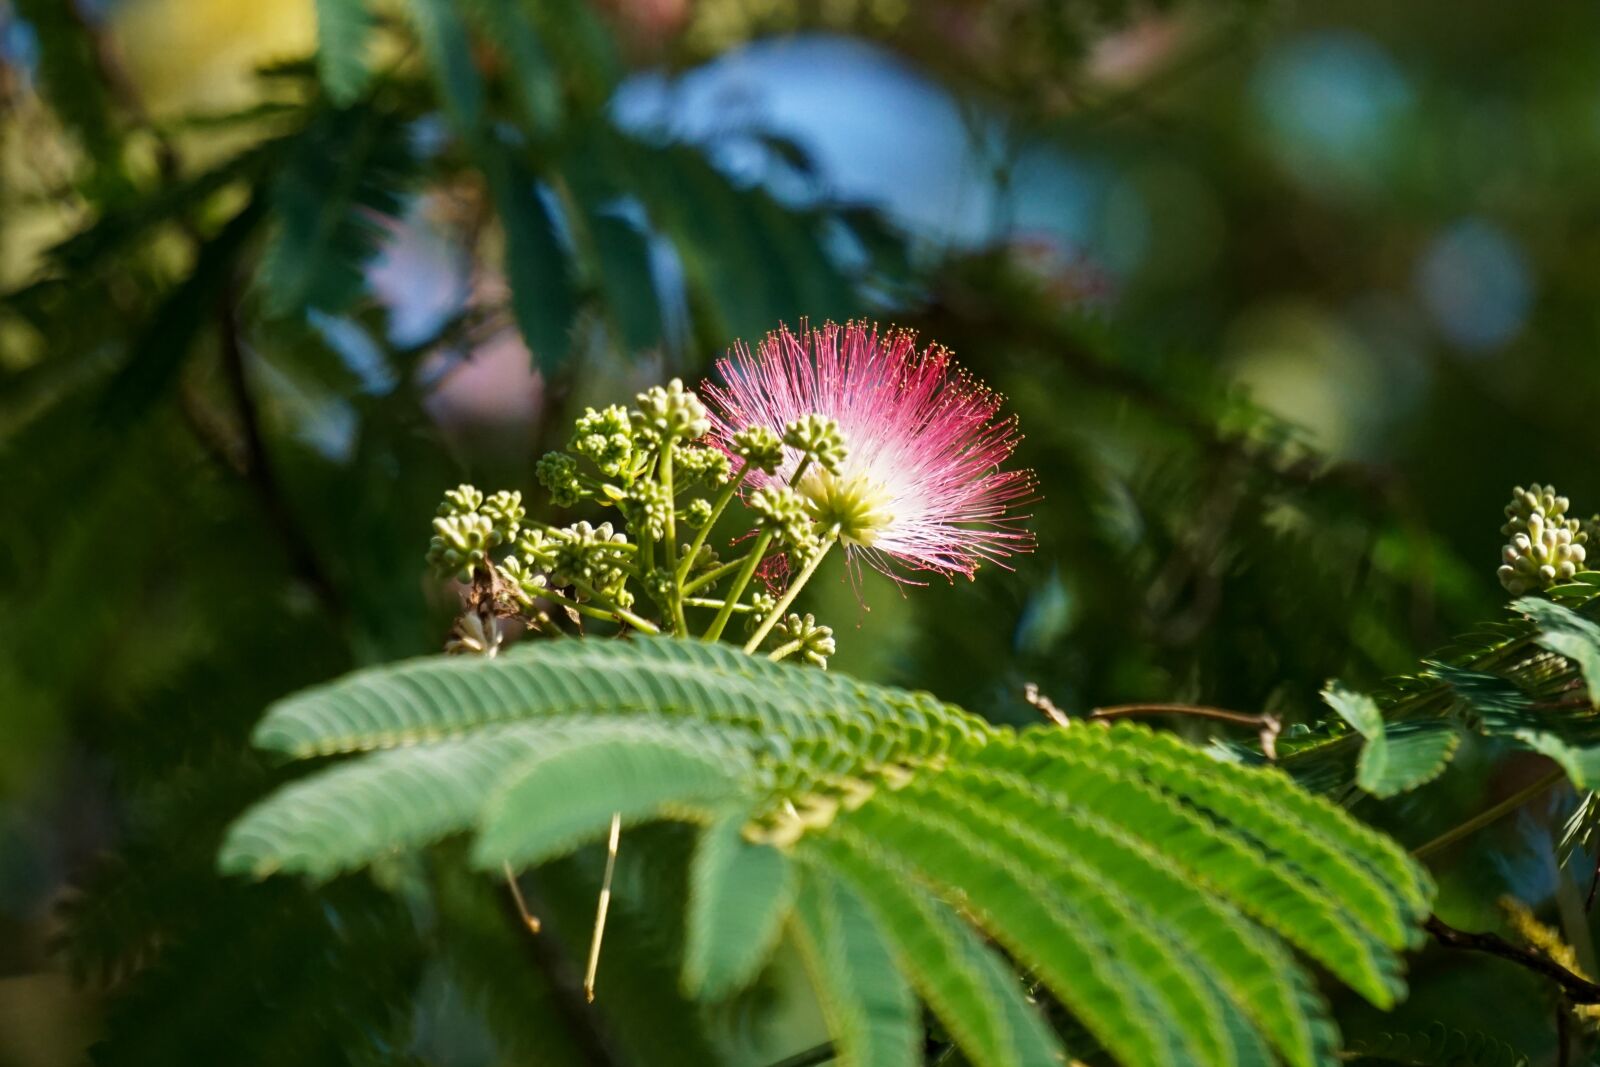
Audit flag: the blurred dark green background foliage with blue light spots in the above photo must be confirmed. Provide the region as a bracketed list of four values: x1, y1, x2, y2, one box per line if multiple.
[0, 0, 1600, 1067]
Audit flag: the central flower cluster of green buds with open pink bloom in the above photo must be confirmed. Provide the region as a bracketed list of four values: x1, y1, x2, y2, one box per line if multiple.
[427, 323, 1032, 667]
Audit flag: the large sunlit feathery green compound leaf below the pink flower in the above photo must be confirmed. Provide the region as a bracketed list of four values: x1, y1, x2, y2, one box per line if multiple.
[221, 638, 1434, 1067]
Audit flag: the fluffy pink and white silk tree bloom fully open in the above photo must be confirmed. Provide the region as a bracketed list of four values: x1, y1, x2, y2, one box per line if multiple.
[704, 323, 1034, 581]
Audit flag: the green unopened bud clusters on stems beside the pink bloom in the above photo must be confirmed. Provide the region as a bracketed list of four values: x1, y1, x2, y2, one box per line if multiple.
[427, 381, 850, 667]
